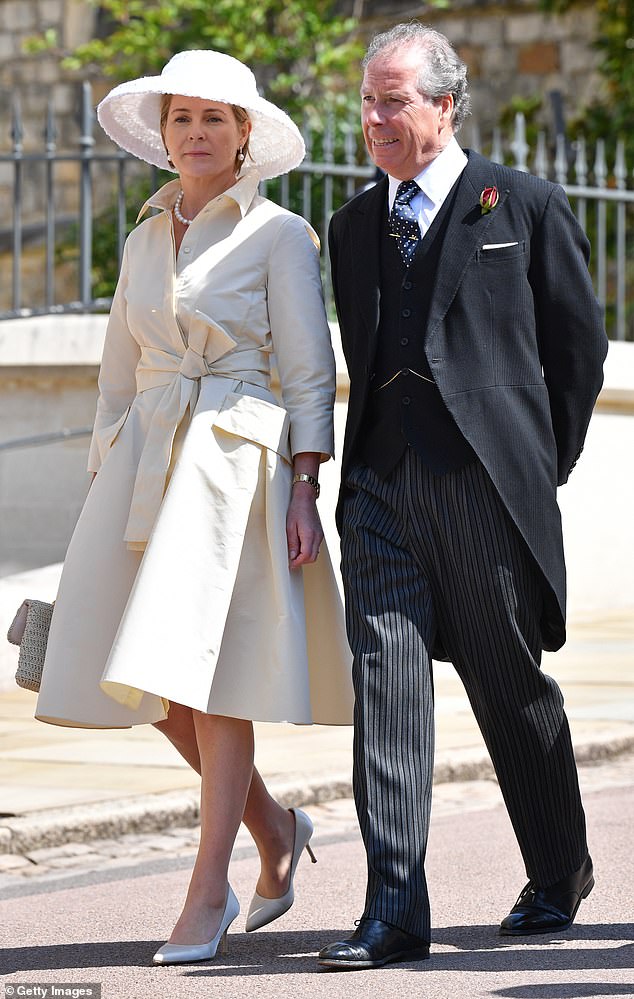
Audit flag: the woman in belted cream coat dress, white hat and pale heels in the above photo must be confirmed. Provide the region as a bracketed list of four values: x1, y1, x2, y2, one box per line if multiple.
[37, 51, 352, 964]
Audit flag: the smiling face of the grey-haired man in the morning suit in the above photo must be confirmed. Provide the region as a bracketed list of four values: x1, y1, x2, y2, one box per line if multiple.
[361, 46, 453, 180]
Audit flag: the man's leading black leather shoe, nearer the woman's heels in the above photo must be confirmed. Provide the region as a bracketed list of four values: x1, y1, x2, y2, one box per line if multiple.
[317, 916, 429, 971]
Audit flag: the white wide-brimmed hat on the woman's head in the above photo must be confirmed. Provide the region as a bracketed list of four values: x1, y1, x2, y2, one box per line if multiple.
[97, 49, 306, 180]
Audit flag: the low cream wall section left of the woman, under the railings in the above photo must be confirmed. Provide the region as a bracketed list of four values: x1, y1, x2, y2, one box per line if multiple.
[0, 316, 105, 576]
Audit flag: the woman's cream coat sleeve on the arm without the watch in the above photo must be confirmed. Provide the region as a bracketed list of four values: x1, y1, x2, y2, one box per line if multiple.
[88, 243, 141, 472]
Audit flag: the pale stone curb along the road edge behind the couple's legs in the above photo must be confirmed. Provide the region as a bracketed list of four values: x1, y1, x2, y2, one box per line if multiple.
[0, 733, 634, 854]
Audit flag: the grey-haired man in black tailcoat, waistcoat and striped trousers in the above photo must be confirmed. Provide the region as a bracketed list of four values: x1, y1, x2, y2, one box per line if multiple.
[319, 23, 607, 969]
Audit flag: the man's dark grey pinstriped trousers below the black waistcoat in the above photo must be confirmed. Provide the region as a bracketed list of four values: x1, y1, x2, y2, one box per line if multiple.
[341, 448, 587, 941]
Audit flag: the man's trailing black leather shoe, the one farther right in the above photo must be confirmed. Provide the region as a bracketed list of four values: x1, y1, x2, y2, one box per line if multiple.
[500, 856, 594, 937]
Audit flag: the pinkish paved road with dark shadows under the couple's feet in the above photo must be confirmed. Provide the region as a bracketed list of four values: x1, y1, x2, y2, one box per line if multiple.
[0, 757, 634, 999]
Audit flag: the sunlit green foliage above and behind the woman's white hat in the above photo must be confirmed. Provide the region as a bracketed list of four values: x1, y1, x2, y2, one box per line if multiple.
[24, 0, 363, 123]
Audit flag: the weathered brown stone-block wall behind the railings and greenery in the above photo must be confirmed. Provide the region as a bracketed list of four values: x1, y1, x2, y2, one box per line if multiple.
[0, 0, 599, 311]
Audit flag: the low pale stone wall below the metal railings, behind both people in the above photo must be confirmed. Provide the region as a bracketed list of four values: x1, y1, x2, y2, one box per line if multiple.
[0, 316, 634, 619]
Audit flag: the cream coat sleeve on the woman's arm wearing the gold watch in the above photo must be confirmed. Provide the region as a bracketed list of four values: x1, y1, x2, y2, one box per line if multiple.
[267, 215, 336, 461]
